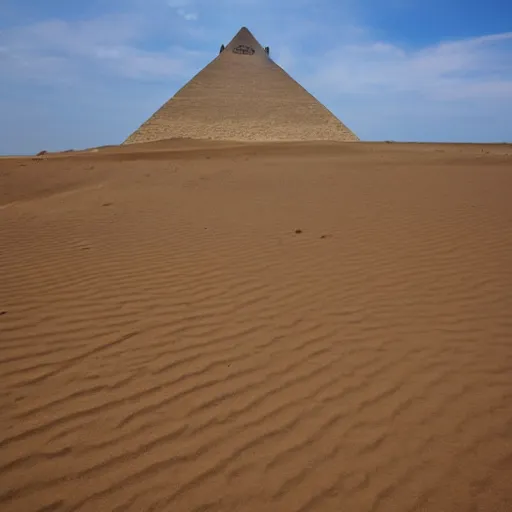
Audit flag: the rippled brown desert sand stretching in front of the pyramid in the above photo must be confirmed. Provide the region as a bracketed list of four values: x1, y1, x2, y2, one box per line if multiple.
[0, 141, 512, 512]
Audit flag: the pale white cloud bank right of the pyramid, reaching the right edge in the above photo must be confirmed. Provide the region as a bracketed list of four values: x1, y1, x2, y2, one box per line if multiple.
[300, 32, 512, 101]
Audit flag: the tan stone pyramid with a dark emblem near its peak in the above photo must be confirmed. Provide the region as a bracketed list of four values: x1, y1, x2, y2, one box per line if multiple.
[124, 27, 359, 144]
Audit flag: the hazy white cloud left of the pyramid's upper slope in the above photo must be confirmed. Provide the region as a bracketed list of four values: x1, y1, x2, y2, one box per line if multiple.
[0, 11, 208, 83]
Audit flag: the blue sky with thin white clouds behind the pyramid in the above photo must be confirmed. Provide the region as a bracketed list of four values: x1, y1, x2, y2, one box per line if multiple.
[0, 0, 512, 154]
